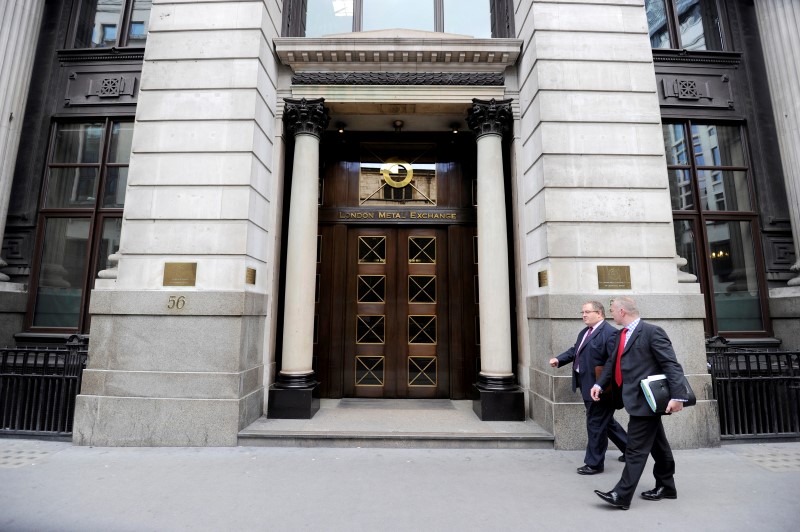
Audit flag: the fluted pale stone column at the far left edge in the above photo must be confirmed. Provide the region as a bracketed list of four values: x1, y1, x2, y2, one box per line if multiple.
[0, 0, 44, 284]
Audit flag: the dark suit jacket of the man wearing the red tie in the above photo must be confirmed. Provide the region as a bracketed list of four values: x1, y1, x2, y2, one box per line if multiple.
[597, 321, 688, 416]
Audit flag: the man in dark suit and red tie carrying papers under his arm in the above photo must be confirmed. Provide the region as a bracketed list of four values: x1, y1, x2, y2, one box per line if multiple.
[591, 297, 688, 510]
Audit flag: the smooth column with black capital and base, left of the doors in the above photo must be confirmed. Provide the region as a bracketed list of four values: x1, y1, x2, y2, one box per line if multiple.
[267, 98, 330, 419]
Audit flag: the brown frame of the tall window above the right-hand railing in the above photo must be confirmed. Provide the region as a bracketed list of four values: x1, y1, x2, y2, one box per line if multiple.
[662, 117, 772, 338]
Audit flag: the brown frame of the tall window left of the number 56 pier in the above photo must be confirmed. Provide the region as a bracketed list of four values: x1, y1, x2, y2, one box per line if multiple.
[24, 116, 130, 334]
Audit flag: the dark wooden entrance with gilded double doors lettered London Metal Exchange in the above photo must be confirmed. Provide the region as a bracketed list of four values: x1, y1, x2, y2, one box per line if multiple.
[314, 136, 479, 398]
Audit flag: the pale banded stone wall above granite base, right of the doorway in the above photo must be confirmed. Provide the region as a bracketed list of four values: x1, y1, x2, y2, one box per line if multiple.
[515, 0, 678, 295]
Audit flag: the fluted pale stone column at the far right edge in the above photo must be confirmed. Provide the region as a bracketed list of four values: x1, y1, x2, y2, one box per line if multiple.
[755, 0, 800, 286]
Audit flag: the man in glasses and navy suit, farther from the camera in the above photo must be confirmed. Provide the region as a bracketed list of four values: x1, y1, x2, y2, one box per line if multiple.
[550, 301, 628, 475]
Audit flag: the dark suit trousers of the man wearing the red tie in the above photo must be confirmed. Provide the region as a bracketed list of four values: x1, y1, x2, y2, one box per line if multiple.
[614, 416, 675, 503]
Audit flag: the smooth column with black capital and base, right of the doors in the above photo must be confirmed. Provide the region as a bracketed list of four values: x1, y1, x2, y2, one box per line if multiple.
[467, 99, 525, 421]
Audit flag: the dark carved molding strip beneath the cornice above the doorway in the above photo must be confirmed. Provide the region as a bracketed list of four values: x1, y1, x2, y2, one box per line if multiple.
[292, 72, 505, 87]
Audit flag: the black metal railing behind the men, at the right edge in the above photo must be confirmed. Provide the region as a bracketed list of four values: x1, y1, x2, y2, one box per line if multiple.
[707, 340, 800, 439]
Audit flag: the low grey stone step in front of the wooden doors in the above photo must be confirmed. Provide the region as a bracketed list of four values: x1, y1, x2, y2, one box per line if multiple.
[239, 399, 553, 449]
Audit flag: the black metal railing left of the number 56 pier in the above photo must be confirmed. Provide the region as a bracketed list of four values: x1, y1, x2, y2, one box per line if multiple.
[0, 335, 87, 436]
